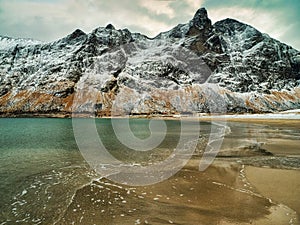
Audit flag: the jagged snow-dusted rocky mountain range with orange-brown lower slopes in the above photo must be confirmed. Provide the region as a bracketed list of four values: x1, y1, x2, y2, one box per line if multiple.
[0, 8, 300, 116]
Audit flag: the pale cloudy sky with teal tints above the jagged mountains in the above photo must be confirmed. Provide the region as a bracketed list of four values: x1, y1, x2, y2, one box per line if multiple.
[0, 0, 300, 50]
